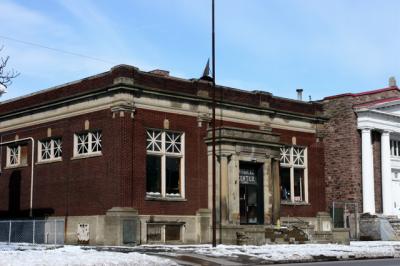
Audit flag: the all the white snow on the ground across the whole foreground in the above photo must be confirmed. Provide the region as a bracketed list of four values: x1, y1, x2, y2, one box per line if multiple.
[0, 241, 400, 266]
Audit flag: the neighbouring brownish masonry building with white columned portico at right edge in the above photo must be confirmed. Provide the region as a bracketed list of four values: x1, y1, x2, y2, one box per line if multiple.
[321, 79, 400, 239]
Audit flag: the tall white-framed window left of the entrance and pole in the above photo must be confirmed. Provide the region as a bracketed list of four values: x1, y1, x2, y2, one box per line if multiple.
[146, 129, 185, 198]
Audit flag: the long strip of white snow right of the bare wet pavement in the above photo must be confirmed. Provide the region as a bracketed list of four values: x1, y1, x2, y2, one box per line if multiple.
[140, 241, 400, 261]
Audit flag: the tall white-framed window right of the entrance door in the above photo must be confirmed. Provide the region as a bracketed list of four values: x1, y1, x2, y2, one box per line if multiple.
[279, 146, 308, 202]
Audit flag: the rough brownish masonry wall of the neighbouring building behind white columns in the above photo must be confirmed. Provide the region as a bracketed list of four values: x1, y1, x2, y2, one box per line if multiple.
[323, 89, 400, 211]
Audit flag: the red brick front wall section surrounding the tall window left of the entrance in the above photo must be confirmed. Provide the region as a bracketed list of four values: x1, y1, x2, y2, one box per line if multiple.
[133, 109, 208, 215]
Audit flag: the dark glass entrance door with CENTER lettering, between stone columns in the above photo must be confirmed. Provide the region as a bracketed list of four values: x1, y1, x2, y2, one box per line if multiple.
[239, 162, 264, 224]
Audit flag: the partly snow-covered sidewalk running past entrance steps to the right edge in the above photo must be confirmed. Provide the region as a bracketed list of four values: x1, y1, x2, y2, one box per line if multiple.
[128, 241, 400, 265]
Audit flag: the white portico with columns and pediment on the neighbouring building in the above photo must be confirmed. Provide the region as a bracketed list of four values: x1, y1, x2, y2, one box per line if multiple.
[355, 99, 400, 216]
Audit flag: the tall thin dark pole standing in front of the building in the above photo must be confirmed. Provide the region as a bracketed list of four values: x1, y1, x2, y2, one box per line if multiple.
[211, 0, 217, 247]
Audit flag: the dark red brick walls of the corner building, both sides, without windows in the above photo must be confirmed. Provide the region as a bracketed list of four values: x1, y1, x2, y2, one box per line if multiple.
[0, 105, 324, 219]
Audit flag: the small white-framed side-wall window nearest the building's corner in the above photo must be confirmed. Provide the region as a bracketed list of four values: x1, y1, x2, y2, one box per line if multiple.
[74, 130, 102, 156]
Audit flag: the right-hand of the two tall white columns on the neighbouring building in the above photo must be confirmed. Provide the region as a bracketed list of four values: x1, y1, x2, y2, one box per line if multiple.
[381, 131, 393, 215]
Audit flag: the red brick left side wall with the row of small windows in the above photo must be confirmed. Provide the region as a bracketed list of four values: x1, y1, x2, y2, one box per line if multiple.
[0, 110, 121, 215]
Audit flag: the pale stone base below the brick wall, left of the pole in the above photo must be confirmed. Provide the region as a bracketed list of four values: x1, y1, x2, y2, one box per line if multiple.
[63, 207, 212, 246]
